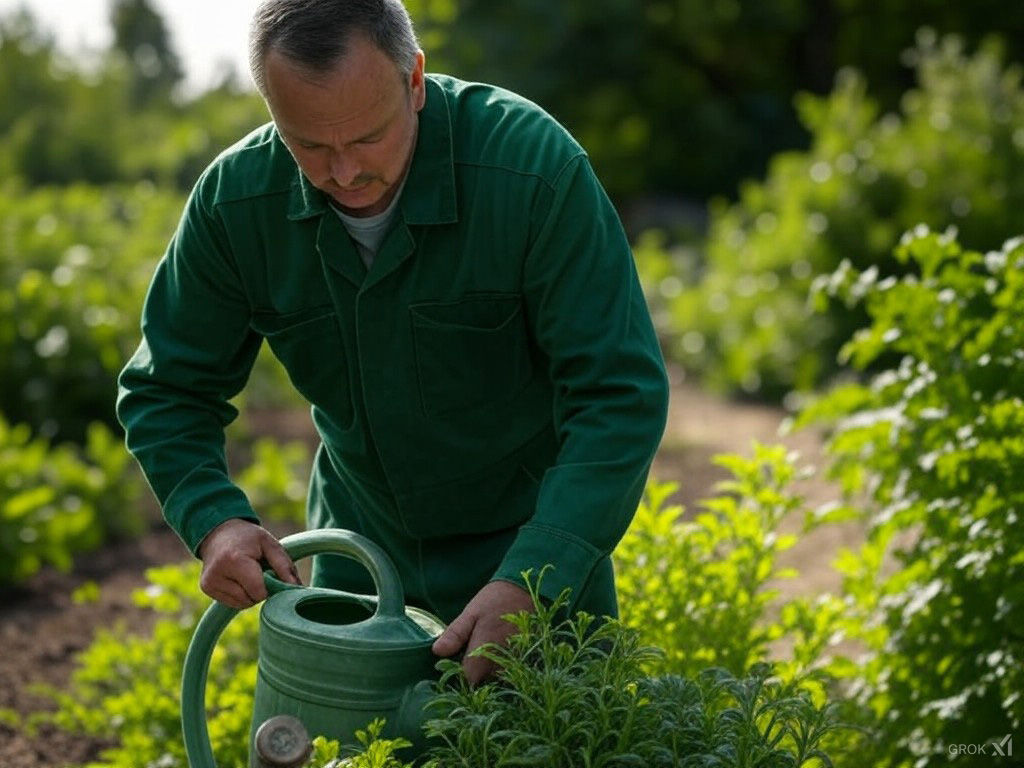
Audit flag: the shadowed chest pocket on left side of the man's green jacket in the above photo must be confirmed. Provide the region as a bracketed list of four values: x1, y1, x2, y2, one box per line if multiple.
[251, 307, 353, 429]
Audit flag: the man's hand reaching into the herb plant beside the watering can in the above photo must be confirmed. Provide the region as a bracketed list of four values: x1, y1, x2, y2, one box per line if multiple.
[433, 582, 534, 685]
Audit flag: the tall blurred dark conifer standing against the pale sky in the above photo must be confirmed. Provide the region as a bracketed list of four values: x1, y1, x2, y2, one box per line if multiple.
[111, 0, 184, 106]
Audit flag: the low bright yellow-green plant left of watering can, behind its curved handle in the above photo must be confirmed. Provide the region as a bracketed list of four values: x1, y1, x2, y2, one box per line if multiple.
[35, 563, 258, 768]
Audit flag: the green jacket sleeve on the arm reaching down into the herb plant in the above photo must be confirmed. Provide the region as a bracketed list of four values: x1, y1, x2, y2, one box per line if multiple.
[495, 155, 668, 602]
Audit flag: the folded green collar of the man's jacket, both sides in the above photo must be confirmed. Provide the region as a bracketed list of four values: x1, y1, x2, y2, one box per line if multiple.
[292, 75, 458, 224]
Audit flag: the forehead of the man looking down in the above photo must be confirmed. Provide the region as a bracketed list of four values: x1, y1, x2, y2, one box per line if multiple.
[264, 38, 406, 137]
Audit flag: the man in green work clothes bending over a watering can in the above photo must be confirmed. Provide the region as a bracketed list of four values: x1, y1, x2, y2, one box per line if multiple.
[118, 0, 667, 682]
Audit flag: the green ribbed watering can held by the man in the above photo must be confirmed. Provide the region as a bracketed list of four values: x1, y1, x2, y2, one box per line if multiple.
[181, 528, 444, 768]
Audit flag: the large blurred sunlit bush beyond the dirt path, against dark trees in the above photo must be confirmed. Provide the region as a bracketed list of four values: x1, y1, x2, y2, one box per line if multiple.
[641, 33, 1024, 397]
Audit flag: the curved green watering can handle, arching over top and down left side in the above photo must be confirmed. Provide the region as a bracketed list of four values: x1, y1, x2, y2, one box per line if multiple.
[181, 528, 406, 768]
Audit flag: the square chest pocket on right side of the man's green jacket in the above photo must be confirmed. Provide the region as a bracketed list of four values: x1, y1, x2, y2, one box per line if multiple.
[409, 294, 531, 417]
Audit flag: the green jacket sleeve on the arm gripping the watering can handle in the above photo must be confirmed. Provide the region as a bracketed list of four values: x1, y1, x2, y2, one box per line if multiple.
[117, 177, 261, 553]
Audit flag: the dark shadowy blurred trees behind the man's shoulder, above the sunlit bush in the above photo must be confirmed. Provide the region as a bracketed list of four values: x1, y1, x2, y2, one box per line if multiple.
[407, 0, 1024, 200]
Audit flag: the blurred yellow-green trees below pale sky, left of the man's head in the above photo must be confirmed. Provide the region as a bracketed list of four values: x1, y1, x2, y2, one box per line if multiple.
[0, 5, 267, 189]
